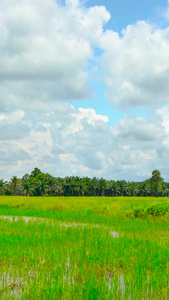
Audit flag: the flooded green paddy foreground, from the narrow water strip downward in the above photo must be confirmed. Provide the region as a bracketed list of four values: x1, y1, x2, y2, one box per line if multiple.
[0, 216, 169, 300]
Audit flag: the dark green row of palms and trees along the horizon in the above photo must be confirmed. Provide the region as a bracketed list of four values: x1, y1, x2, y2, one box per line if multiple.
[0, 168, 169, 197]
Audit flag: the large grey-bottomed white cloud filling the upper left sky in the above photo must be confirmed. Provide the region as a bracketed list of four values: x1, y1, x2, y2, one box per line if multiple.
[0, 0, 110, 110]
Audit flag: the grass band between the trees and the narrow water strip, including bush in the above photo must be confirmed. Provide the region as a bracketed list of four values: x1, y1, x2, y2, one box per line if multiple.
[0, 196, 169, 223]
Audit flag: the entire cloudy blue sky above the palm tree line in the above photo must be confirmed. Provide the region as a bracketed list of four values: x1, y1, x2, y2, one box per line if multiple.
[0, 0, 169, 181]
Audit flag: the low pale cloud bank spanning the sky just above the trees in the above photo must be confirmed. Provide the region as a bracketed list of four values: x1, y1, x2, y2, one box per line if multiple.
[0, 104, 169, 180]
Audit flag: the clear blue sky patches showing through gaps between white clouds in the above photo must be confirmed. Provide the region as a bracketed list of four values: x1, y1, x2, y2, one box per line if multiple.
[72, 0, 169, 126]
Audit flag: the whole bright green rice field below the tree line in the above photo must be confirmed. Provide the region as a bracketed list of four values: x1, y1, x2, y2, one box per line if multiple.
[0, 197, 169, 300]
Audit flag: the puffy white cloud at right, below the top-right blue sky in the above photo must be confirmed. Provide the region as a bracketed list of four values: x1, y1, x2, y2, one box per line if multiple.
[101, 21, 169, 109]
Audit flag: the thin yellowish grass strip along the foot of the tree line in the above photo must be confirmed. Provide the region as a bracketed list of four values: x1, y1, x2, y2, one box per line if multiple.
[0, 196, 169, 211]
